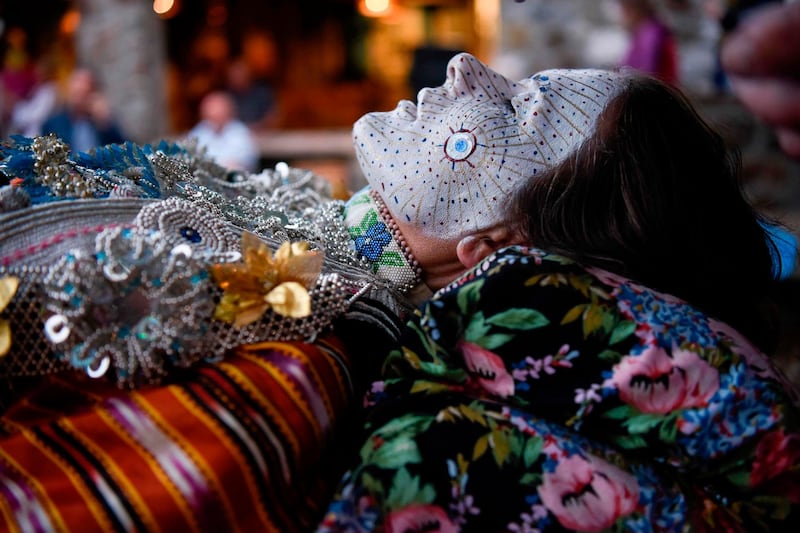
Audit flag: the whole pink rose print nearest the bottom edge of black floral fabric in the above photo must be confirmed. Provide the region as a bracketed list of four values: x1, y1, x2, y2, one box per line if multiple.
[539, 455, 639, 531]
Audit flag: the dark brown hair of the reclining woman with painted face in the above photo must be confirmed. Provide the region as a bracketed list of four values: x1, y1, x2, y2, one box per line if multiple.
[510, 71, 775, 351]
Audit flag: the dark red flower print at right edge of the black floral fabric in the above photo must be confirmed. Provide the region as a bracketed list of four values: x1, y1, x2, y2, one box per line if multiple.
[750, 430, 800, 503]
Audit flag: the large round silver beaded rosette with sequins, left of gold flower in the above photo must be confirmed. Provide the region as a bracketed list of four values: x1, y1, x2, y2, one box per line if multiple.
[43, 228, 213, 386]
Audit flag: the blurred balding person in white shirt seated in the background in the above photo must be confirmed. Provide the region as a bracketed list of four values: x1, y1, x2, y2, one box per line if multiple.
[187, 91, 259, 172]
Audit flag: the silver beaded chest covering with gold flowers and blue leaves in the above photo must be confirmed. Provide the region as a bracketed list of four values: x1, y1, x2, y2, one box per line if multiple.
[0, 136, 405, 387]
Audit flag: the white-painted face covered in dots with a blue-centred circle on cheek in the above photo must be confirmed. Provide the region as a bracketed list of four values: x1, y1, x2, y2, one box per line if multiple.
[353, 53, 624, 239]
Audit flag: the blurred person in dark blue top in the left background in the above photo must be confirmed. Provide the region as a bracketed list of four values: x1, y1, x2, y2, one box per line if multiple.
[42, 68, 125, 152]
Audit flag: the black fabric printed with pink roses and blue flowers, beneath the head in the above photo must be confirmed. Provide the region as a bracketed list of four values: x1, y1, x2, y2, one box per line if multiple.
[319, 247, 800, 532]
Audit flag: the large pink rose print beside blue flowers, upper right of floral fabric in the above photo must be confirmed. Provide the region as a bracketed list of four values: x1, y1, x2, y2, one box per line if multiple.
[611, 346, 719, 414]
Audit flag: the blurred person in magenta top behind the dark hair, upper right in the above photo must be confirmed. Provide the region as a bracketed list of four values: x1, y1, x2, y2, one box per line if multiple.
[619, 0, 679, 85]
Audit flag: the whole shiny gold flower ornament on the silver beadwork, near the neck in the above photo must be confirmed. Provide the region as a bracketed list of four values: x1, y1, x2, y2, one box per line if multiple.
[216, 232, 322, 327]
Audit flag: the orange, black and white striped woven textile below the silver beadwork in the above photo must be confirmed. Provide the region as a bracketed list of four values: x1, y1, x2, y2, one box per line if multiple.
[0, 337, 353, 533]
